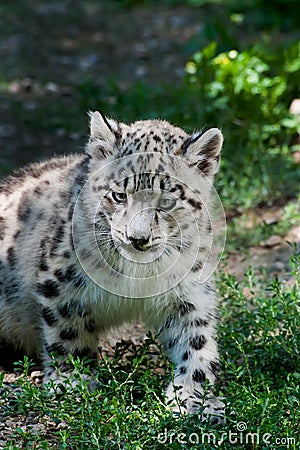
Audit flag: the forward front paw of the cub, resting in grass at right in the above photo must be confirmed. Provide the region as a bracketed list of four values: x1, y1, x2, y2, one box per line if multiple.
[166, 383, 226, 425]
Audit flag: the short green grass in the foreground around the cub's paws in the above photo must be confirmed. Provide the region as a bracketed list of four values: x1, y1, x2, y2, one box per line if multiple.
[0, 253, 300, 449]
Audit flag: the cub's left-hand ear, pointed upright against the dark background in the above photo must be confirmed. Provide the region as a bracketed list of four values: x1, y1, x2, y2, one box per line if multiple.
[86, 111, 119, 159]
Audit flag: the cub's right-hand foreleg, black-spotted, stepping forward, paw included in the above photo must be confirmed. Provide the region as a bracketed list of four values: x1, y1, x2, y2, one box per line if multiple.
[159, 294, 225, 423]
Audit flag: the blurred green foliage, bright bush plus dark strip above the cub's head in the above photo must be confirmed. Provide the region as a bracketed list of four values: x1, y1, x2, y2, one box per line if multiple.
[78, 41, 300, 209]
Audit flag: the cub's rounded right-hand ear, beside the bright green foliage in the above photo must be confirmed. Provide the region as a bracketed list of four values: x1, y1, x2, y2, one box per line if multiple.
[185, 128, 223, 179]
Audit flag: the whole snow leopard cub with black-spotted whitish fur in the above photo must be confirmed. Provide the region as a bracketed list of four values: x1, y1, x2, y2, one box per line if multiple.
[0, 112, 224, 420]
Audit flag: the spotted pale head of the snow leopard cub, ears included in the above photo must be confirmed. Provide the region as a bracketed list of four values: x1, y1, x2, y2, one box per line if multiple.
[72, 112, 223, 296]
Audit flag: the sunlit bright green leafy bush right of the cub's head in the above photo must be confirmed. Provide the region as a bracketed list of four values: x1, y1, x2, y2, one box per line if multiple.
[186, 42, 299, 208]
